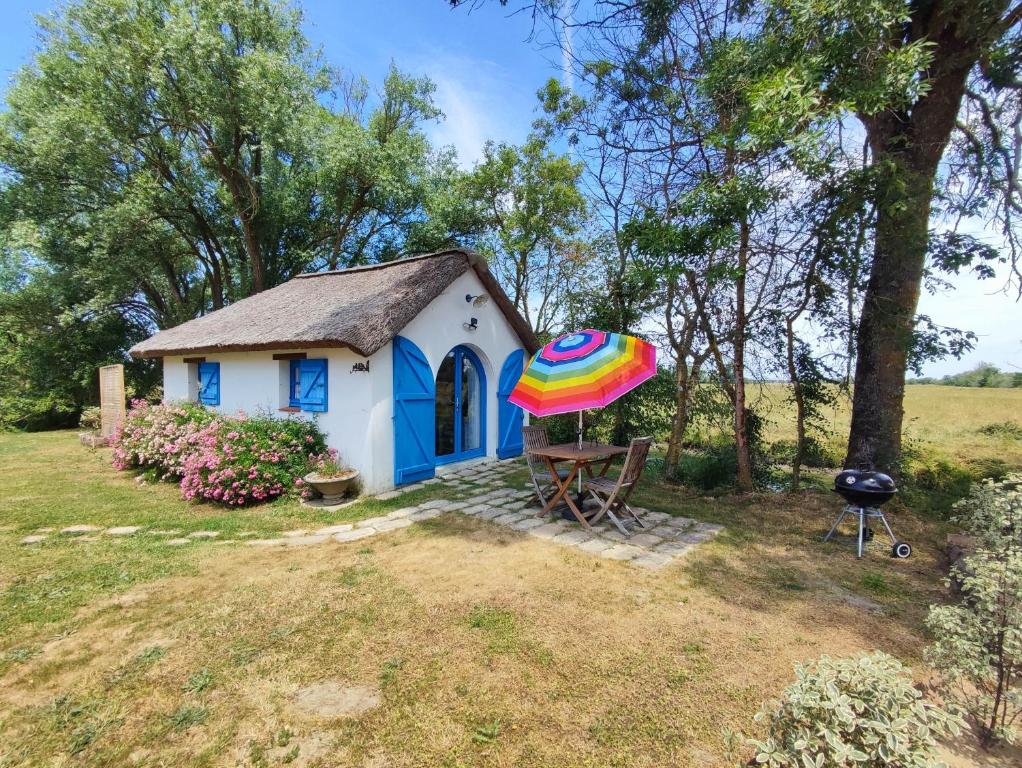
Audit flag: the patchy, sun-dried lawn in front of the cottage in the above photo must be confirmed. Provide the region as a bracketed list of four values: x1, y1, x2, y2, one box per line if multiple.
[0, 433, 1019, 768]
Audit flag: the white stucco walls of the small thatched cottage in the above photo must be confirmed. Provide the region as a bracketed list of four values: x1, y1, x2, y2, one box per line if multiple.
[164, 263, 521, 493]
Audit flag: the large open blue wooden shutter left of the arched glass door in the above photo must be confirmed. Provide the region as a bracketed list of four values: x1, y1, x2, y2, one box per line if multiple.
[393, 336, 436, 486]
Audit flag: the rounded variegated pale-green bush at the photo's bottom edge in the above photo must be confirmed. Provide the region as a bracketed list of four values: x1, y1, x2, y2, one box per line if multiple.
[751, 651, 960, 768]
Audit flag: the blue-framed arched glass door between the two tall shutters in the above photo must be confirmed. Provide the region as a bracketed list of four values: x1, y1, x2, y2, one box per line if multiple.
[435, 346, 486, 464]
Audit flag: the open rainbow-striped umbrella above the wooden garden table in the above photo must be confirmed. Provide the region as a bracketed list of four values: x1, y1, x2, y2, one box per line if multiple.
[508, 328, 656, 421]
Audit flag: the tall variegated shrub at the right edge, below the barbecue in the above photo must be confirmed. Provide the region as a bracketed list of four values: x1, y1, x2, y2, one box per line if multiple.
[926, 476, 1022, 746]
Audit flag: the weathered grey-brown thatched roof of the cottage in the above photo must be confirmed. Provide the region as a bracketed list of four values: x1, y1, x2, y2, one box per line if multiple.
[131, 250, 539, 357]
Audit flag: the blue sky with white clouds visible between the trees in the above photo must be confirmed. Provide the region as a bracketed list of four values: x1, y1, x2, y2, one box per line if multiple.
[0, 0, 1022, 375]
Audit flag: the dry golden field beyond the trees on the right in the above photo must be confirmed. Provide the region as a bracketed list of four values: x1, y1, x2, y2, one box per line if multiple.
[749, 385, 1022, 469]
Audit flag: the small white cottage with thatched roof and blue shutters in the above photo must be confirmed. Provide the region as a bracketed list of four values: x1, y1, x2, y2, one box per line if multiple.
[131, 250, 539, 492]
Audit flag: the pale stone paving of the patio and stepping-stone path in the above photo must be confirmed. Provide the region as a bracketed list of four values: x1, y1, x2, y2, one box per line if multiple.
[15, 460, 723, 569]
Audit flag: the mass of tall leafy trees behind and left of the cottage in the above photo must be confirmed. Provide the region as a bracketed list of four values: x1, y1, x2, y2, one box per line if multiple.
[0, 0, 480, 428]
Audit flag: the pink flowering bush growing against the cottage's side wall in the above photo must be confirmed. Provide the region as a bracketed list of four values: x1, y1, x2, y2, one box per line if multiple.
[113, 401, 329, 506]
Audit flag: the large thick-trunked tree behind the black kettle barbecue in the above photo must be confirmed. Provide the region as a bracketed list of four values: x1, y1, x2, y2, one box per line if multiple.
[750, 0, 1022, 467]
